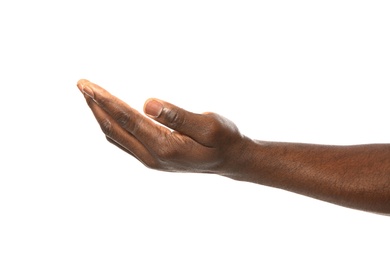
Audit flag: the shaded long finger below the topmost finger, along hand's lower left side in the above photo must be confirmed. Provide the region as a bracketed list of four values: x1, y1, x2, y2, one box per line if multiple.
[86, 96, 155, 167]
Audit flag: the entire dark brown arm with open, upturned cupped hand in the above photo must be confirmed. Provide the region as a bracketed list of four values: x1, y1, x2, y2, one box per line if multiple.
[77, 79, 390, 214]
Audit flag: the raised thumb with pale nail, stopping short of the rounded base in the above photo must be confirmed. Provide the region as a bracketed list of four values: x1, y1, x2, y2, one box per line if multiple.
[144, 99, 211, 143]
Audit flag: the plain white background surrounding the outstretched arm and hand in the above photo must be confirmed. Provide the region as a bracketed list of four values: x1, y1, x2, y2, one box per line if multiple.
[0, 0, 390, 260]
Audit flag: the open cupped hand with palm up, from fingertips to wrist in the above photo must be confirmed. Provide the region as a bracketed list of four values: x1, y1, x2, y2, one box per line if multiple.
[77, 79, 246, 173]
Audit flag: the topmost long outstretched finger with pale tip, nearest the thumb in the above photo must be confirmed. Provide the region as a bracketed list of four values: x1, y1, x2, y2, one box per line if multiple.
[77, 80, 170, 148]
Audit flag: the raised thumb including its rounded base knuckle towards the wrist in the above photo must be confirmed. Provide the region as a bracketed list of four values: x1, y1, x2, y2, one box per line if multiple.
[144, 99, 223, 146]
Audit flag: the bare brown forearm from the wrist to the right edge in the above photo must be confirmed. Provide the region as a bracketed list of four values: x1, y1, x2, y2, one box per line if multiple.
[226, 139, 390, 214]
